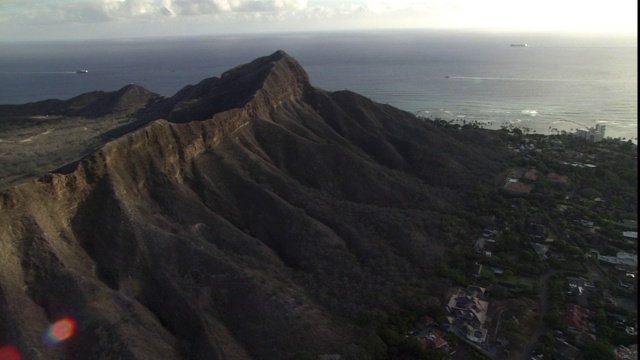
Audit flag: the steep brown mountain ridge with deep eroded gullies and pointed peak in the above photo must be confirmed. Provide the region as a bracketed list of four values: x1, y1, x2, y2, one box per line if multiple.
[0, 51, 510, 359]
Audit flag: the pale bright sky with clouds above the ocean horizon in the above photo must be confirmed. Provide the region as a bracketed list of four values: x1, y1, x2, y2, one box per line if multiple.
[0, 0, 638, 41]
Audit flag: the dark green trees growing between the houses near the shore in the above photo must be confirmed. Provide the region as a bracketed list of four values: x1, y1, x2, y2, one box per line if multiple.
[410, 119, 637, 359]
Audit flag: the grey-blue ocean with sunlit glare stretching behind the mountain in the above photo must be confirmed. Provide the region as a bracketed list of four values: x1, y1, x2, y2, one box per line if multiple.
[0, 31, 638, 139]
